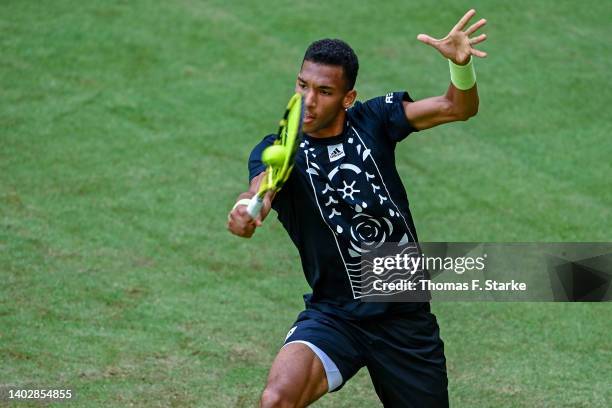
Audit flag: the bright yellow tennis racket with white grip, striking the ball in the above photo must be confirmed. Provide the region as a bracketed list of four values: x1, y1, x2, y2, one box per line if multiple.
[247, 93, 304, 218]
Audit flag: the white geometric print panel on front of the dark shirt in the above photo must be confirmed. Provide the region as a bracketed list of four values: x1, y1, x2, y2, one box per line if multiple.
[302, 126, 414, 299]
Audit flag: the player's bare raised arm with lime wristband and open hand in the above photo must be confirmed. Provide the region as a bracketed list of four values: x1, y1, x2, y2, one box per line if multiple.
[404, 9, 487, 130]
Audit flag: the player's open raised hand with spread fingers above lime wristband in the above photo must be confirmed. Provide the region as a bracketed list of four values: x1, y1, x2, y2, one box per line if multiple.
[417, 9, 487, 65]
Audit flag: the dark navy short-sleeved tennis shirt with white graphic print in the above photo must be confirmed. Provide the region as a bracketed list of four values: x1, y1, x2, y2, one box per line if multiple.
[249, 92, 420, 319]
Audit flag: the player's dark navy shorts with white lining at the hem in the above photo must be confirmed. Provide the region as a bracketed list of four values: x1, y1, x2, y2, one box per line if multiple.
[285, 303, 448, 408]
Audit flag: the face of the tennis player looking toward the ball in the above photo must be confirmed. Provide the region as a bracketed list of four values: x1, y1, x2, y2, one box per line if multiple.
[295, 61, 355, 136]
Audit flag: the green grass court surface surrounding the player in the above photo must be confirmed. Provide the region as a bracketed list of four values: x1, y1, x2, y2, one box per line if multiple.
[0, 0, 612, 407]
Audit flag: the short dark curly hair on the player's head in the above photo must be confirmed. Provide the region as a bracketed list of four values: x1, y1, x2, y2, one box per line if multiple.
[302, 38, 359, 90]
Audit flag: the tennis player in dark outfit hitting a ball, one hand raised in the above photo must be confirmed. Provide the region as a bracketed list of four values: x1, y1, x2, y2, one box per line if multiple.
[228, 10, 486, 407]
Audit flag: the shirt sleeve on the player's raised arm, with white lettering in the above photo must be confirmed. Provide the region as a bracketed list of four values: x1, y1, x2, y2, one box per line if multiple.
[363, 91, 418, 142]
